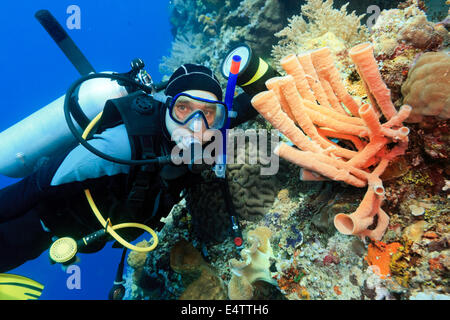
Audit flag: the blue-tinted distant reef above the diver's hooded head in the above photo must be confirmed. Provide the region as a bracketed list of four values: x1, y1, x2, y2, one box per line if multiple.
[160, 0, 300, 77]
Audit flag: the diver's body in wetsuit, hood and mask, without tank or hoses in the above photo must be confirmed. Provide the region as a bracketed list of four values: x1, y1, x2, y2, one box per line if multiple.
[0, 64, 257, 272]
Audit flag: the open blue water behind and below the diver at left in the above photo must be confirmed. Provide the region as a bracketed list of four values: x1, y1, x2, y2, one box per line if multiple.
[0, 0, 172, 299]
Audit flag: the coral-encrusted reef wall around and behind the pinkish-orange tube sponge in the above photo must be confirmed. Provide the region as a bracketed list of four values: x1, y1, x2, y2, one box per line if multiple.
[128, 0, 450, 300]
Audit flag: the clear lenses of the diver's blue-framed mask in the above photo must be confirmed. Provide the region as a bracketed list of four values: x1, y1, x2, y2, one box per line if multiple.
[170, 95, 226, 129]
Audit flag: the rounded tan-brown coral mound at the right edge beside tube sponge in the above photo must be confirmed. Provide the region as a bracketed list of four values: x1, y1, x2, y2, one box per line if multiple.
[402, 52, 450, 122]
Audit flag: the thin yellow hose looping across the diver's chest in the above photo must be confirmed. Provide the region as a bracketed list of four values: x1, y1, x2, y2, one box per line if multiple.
[82, 112, 158, 252]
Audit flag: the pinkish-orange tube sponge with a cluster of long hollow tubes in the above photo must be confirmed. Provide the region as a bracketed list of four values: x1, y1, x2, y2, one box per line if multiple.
[252, 44, 411, 240]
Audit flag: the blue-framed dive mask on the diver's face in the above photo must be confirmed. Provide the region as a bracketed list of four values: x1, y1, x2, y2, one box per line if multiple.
[168, 92, 228, 132]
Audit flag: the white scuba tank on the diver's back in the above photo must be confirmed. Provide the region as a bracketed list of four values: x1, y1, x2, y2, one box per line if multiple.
[0, 78, 128, 178]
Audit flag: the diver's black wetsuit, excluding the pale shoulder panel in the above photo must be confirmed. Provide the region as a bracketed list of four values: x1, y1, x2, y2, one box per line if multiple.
[0, 94, 257, 272]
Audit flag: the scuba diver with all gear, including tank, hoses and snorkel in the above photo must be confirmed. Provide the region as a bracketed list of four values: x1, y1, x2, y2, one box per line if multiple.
[0, 14, 278, 299]
